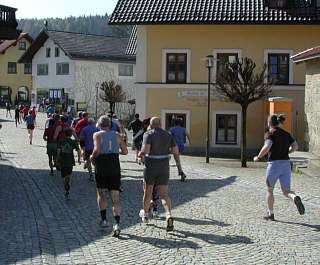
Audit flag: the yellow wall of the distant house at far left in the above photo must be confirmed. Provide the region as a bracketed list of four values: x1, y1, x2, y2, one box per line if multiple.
[0, 38, 32, 103]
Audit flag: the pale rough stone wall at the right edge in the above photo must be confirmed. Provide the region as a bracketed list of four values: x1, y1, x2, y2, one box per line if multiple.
[305, 60, 320, 156]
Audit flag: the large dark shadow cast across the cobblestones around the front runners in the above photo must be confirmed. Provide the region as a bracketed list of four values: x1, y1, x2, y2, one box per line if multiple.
[0, 160, 245, 264]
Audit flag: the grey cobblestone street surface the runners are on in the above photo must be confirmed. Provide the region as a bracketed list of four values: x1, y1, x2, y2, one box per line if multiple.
[0, 110, 320, 265]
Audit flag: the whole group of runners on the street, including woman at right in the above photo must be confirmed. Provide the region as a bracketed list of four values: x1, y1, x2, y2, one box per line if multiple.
[0, 106, 305, 237]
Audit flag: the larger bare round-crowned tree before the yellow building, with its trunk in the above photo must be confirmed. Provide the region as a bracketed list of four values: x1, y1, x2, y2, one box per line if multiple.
[216, 57, 272, 167]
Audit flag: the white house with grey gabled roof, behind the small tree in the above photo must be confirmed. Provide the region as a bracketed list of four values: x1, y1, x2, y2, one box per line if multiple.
[19, 29, 136, 118]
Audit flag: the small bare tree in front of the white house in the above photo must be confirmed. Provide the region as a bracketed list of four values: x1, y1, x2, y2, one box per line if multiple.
[100, 80, 126, 113]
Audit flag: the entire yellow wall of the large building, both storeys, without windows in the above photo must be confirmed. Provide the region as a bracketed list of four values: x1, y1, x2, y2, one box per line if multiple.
[142, 25, 312, 148]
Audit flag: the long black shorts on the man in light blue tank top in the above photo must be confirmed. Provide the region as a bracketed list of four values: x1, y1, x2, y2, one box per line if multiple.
[95, 154, 121, 191]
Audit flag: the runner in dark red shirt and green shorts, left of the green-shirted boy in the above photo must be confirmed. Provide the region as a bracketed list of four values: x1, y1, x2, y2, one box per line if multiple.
[43, 119, 57, 176]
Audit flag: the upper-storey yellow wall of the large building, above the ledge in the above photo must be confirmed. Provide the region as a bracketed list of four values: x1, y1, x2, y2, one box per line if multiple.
[147, 25, 320, 84]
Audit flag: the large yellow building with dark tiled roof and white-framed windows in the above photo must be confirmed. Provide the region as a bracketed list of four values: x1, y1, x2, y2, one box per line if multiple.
[109, 0, 320, 154]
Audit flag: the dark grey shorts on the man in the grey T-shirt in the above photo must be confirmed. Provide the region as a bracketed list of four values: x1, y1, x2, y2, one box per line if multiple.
[143, 158, 169, 185]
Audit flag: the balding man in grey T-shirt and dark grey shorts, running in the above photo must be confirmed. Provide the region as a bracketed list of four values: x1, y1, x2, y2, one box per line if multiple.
[139, 117, 179, 232]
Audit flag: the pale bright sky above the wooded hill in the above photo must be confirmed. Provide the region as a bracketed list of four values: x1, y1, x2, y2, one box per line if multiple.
[0, 0, 118, 19]
